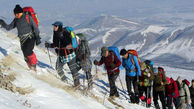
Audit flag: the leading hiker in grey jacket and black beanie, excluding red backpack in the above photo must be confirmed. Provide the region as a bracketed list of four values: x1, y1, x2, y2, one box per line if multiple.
[0, 5, 41, 71]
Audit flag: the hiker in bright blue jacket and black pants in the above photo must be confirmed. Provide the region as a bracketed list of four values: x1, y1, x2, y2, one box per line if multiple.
[120, 49, 141, 104]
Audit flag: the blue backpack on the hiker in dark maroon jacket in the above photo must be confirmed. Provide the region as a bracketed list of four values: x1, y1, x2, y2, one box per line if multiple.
[108, 46, 124, 70]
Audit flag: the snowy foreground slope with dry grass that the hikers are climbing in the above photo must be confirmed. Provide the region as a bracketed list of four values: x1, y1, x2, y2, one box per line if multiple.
[0, 29, 150, 109]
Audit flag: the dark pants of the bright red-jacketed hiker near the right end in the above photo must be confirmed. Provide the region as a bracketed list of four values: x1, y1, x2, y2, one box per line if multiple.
[167, 97, 180, 109]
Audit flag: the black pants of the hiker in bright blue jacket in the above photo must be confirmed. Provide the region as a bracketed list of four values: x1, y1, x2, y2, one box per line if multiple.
[125, 75, 139, 103]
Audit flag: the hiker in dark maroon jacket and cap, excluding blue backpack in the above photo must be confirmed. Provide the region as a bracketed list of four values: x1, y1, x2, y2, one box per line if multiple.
[94, 47, 121, 98]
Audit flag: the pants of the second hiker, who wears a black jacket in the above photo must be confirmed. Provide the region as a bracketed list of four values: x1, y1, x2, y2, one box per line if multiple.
[56, 57, 80, 86]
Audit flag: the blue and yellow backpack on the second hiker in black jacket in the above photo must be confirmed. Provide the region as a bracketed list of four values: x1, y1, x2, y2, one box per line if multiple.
[64, 26, 78, 48]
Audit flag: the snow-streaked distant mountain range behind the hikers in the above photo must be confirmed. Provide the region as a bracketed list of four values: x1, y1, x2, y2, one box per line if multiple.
[75, 15, 194, 70]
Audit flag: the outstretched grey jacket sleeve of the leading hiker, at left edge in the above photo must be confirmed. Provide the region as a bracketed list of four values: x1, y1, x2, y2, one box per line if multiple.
[0, 19, 16, 31]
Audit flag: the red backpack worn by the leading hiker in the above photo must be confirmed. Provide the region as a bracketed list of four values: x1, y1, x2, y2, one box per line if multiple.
[23, 7, 39, 27]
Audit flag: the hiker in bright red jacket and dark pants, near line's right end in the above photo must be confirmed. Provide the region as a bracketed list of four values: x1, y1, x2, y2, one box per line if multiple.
[165, 77, 180, 109]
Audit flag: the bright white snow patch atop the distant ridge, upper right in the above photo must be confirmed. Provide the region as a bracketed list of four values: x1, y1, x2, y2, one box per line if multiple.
[141, 25, 168, 36]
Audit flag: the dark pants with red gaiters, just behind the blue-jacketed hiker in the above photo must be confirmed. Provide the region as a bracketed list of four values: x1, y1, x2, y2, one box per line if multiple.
[138, 86, 151, 107]
